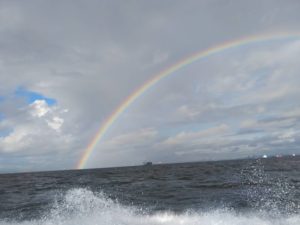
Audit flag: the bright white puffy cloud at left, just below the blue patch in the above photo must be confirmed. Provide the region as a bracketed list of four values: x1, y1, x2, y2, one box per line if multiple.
[0, 100, 73, 157]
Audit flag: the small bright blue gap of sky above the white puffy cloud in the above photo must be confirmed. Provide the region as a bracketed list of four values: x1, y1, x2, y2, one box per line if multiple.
[15, 87, 57, 106]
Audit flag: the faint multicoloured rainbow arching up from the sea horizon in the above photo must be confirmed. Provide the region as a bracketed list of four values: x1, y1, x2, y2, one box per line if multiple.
[76, 32, 300, 169]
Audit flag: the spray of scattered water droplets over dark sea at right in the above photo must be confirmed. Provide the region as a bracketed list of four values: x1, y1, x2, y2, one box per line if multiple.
[241, 159, 300, 214]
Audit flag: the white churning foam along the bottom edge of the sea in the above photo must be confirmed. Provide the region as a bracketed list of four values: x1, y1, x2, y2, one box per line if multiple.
[0, 189, 300, 225]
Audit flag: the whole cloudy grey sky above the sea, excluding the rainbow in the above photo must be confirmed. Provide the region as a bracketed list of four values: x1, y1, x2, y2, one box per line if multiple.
[0, 0, 300, 173]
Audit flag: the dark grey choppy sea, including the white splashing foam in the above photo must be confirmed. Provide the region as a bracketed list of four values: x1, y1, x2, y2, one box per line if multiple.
[0, 156, 300, 225]
